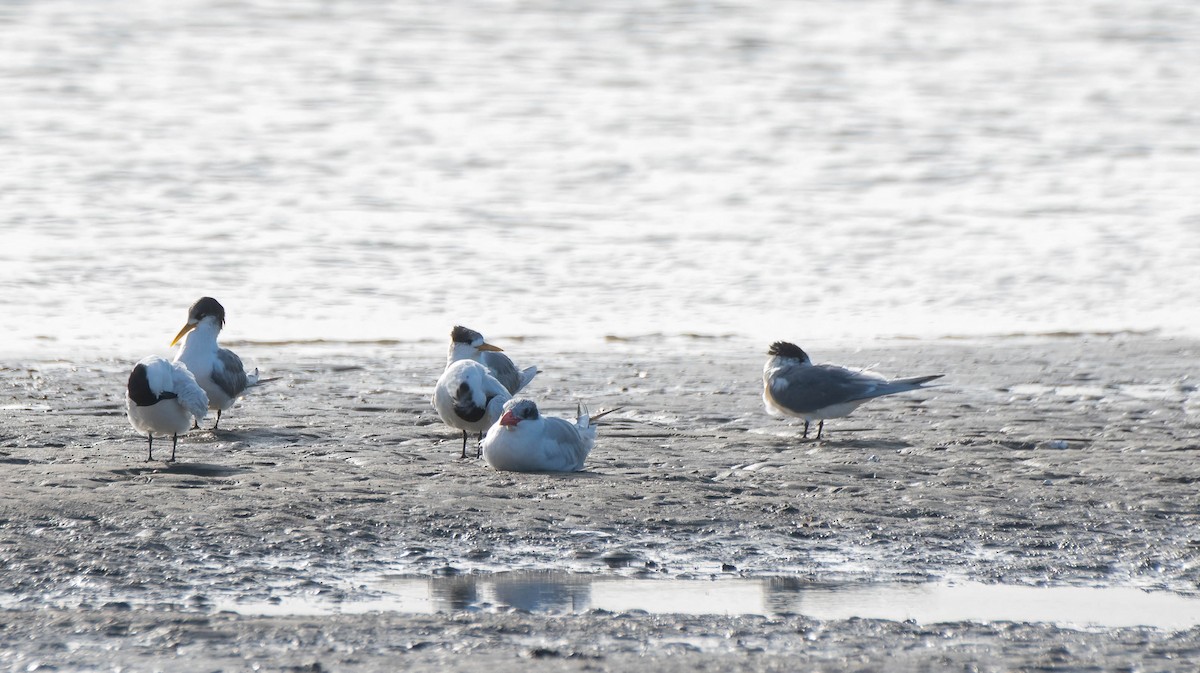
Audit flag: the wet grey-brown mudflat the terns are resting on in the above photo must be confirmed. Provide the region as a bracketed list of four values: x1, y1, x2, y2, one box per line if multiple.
[0, 336, 1200, 671]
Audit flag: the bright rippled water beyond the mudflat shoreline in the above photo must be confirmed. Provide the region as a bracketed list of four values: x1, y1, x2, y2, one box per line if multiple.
[0, 0, 1200, 356]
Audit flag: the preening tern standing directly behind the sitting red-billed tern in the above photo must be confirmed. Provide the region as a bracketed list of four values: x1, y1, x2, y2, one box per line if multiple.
[433, 360, 512, 458]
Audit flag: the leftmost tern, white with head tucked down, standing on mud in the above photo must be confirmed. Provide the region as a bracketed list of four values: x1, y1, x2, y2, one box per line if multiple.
[125, 355, 209, 462]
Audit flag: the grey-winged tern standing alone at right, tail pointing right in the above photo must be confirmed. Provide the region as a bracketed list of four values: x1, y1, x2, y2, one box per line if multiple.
[762, 341, 944, 439]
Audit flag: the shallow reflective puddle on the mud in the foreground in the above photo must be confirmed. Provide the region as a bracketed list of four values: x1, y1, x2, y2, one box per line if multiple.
[215, 572, 1200, 630]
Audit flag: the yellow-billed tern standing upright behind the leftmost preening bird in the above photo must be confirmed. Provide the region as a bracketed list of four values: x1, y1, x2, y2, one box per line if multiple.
[170, 296, 258, 429]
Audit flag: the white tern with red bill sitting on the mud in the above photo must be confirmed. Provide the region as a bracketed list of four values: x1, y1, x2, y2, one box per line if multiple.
[484, 398, 616, 471]
